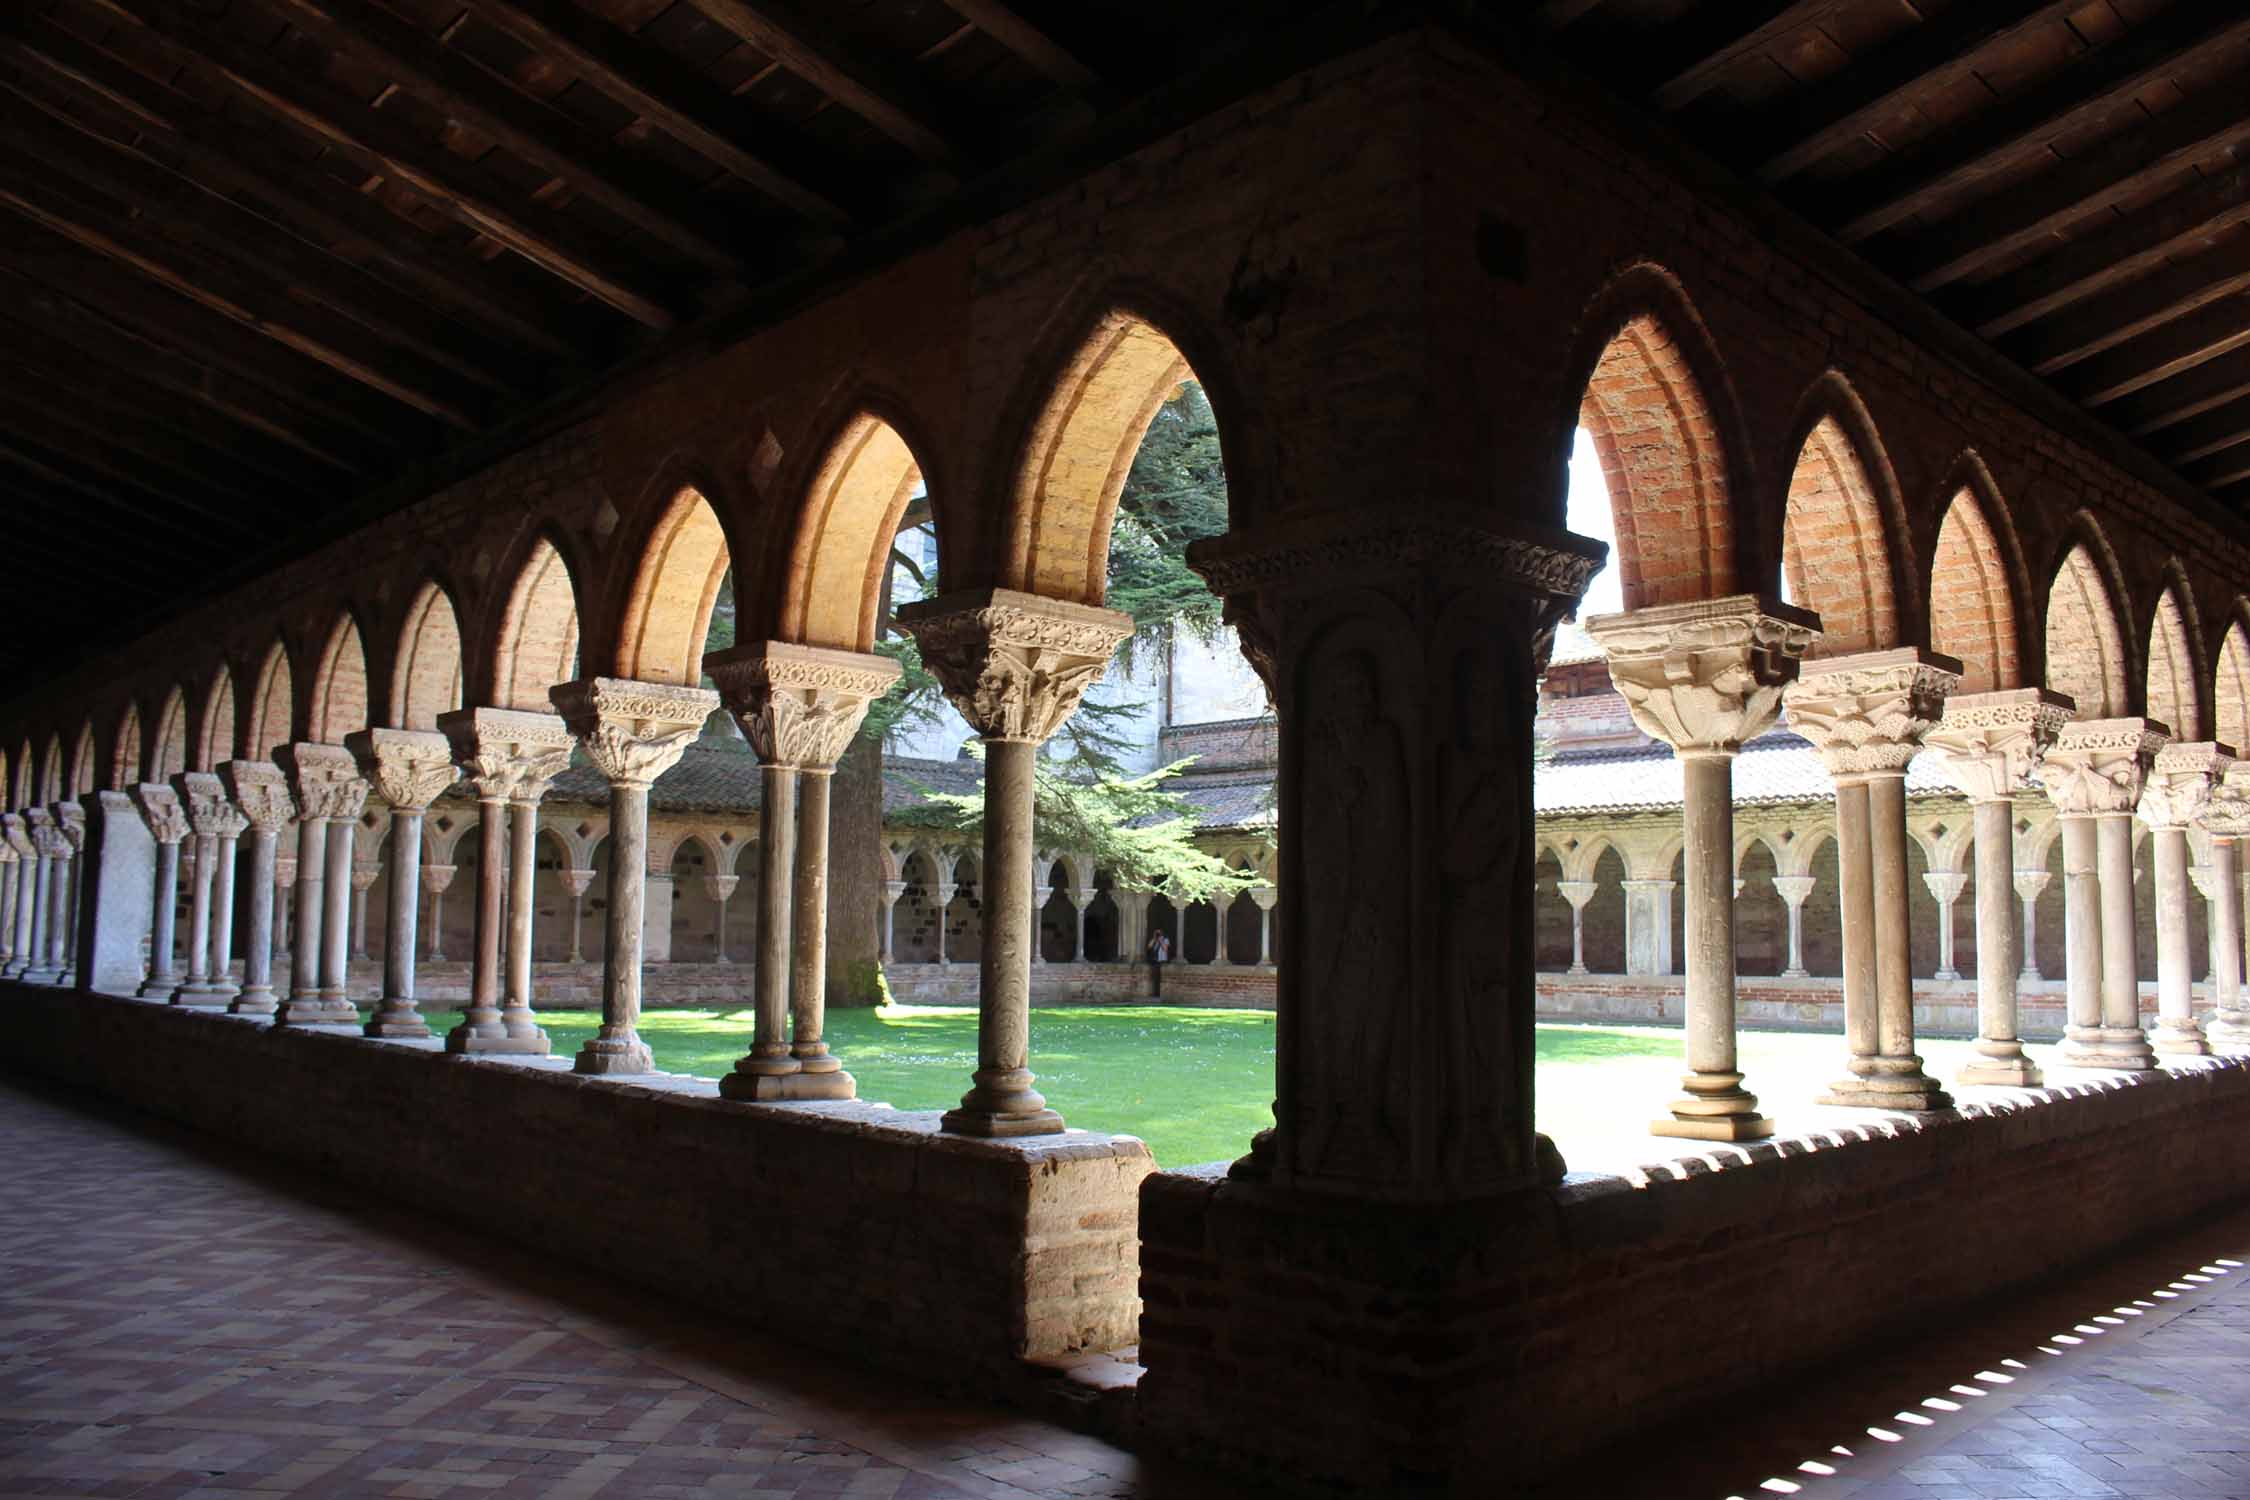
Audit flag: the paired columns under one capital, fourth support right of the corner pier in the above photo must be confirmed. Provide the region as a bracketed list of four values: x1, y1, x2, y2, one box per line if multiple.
[2041, 720, 2171, 1070]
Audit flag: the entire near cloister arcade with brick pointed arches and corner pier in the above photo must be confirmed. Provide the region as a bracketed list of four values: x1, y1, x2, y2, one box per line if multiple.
[13, 31, 2250, 1482]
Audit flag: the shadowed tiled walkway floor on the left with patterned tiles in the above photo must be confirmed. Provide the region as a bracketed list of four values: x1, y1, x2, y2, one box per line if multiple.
[0, 1075, 1242, 1500]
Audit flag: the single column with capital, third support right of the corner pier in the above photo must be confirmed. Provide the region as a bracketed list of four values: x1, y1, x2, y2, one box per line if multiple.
[1928, 688, 2072, 1088]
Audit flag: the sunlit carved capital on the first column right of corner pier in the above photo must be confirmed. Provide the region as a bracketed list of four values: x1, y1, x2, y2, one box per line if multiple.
[1586, 594, 1820, 756]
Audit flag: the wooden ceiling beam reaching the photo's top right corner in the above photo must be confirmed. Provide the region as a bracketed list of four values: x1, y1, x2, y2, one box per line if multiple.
[1809, 7, 2250, 245]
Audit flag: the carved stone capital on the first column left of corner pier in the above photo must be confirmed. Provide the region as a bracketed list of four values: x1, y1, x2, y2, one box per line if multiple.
[891, 589, 1132, 753]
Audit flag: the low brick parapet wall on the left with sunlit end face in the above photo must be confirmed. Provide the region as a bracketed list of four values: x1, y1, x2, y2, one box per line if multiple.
[0, 983, 1152, 1390]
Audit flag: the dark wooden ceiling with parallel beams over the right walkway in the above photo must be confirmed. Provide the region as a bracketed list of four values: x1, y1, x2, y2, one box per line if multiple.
[1535, 0, 2250, 515]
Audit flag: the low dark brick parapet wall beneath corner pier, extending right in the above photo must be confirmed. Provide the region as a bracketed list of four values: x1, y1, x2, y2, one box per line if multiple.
[1139, 1059, 2250, 1493]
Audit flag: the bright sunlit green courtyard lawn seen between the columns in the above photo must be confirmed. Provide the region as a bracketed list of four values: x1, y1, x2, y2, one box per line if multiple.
[430, 1005, 1969, 1172]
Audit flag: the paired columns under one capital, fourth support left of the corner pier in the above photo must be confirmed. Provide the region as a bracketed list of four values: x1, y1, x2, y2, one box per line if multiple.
[437, 708, 567, 1057]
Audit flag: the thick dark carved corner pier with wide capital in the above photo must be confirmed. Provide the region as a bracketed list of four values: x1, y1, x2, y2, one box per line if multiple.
[1188, 512, 1607, 1203]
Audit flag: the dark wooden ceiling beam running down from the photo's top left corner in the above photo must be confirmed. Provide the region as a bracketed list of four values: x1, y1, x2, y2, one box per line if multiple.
[0, 20, 585, 362]
